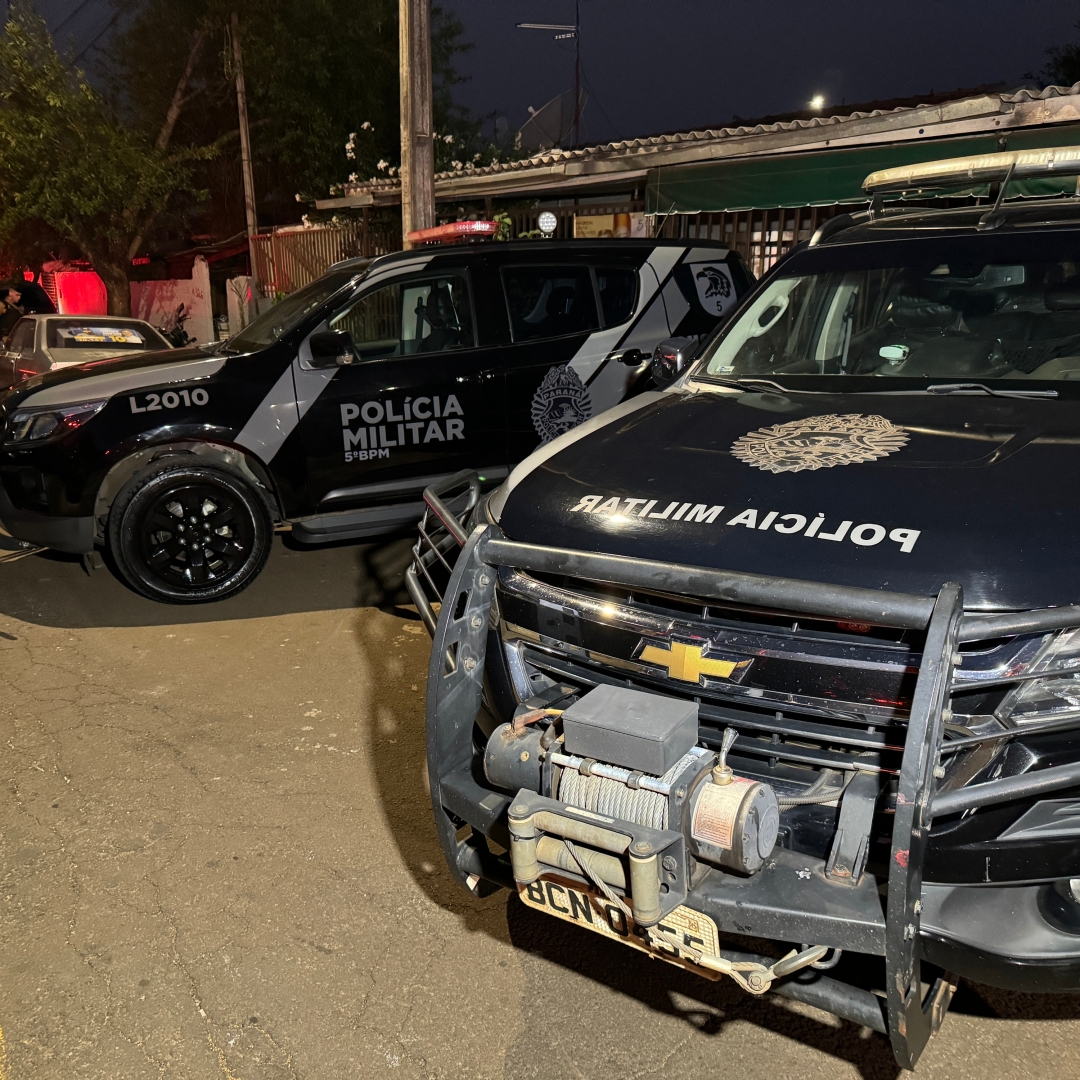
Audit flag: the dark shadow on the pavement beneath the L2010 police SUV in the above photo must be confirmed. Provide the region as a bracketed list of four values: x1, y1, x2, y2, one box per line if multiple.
[0, 531, 415, 629]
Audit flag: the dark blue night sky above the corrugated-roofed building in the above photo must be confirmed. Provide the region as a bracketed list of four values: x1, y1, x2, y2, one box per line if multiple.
[440, 0, 1080, 143]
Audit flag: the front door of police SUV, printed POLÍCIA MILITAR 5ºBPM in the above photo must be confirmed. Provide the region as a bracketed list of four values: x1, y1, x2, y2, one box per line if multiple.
[297, 259, 507, 513]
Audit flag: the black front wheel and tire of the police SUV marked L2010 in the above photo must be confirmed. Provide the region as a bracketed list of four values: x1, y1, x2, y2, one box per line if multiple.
[108, 459, 273, 604]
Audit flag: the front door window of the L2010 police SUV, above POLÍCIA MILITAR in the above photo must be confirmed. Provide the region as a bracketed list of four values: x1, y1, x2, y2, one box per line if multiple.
[329, 273, 476, 360]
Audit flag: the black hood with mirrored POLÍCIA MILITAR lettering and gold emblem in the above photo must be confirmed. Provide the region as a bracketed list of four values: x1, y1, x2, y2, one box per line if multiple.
[500, 388, 1080, 610]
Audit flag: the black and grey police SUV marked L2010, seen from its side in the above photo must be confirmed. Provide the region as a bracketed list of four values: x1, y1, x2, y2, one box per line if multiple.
[0, 240, 753, 603]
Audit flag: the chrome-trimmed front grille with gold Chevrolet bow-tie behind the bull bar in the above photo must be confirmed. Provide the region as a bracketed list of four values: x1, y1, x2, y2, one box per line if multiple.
[498, 567, 1034, 783]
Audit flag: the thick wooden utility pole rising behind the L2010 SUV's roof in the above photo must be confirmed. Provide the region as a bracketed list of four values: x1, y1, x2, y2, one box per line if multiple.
[399, 0, 435, 249]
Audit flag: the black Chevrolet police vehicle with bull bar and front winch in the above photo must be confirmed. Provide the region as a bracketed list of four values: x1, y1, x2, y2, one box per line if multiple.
[413, 149, 1080, 1068]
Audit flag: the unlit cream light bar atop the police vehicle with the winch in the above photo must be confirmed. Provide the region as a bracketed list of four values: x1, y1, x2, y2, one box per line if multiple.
[863, 146, 1080, 195]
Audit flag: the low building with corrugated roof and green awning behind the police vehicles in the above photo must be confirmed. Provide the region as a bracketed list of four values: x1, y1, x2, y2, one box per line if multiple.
[316, 83, 1080, 273]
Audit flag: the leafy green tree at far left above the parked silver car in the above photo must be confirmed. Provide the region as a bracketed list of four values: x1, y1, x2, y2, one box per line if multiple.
[0, 4, 216, 315]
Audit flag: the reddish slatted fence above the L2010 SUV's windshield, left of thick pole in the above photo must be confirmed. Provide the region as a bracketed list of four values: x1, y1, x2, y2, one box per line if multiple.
[252, 220, 401, 297]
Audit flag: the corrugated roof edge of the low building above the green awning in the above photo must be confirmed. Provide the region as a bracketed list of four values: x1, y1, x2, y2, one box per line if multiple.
[316, 82, 1080, 210]
